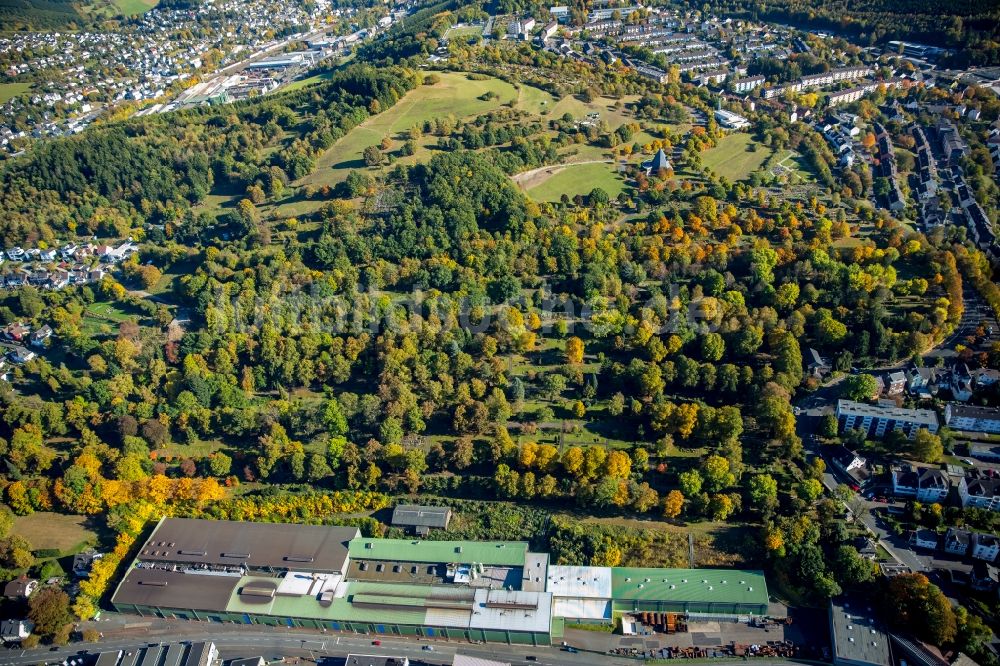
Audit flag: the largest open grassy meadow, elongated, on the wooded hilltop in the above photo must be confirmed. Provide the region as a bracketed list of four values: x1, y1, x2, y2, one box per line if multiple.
[302, 72, 524, 186]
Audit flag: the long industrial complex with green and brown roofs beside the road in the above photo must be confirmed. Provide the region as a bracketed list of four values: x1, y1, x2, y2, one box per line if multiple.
[111, 518, 768, 640]
